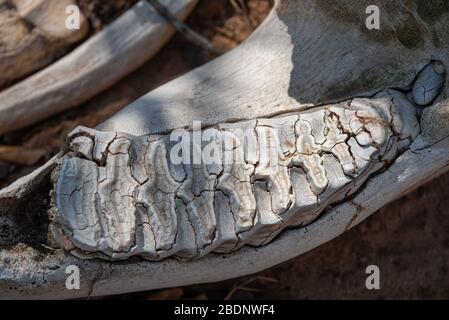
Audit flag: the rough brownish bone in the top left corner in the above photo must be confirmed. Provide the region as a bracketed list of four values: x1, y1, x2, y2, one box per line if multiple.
[0, 0, 89, 89]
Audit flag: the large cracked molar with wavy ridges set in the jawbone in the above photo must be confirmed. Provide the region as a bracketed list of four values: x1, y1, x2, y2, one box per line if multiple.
[53, 90, 420, 260]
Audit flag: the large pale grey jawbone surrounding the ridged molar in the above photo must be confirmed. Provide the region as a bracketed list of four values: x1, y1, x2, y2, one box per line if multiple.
[0, 0, 449, 298]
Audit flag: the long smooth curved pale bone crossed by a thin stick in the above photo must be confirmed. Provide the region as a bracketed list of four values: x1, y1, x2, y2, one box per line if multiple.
[0, 0, 197, 134]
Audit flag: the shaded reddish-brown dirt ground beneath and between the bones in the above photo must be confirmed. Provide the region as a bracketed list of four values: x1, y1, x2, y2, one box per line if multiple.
[0, 0, 449, 299]
